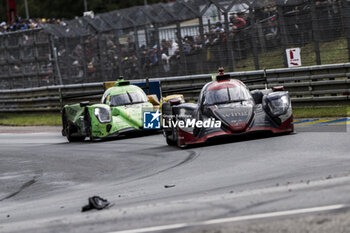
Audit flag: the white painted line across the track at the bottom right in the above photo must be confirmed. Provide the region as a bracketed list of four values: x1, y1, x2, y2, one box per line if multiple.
[109, 205, 346, 233]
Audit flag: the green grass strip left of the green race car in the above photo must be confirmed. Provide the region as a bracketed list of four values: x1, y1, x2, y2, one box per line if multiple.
[0, 113, 62, 126]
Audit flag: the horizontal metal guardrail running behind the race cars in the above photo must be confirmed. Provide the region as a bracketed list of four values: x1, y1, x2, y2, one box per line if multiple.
[0, 63, 350, 112]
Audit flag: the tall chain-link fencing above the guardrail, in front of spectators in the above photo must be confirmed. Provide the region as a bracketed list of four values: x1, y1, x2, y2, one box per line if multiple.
[0, 0, 350, 89]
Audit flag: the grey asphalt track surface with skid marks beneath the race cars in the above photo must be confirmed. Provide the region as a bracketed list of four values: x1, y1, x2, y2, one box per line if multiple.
[0, 120, 350, 233]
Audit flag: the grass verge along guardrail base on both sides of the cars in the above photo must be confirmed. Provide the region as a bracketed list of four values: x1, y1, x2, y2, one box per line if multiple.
[0, 106, 350, 126]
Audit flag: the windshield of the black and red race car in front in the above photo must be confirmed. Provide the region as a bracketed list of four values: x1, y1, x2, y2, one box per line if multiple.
[205, 86, 251, 105]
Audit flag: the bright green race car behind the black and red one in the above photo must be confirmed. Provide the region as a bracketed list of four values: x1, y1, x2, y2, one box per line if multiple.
[62, 80, 159, 142]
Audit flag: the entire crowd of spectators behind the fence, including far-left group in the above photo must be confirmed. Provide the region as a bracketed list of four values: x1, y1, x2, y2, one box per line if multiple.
[0, 0, 341, 81]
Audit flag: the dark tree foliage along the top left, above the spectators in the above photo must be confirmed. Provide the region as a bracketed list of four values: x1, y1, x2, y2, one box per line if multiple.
[0, 0, 168, 21]
